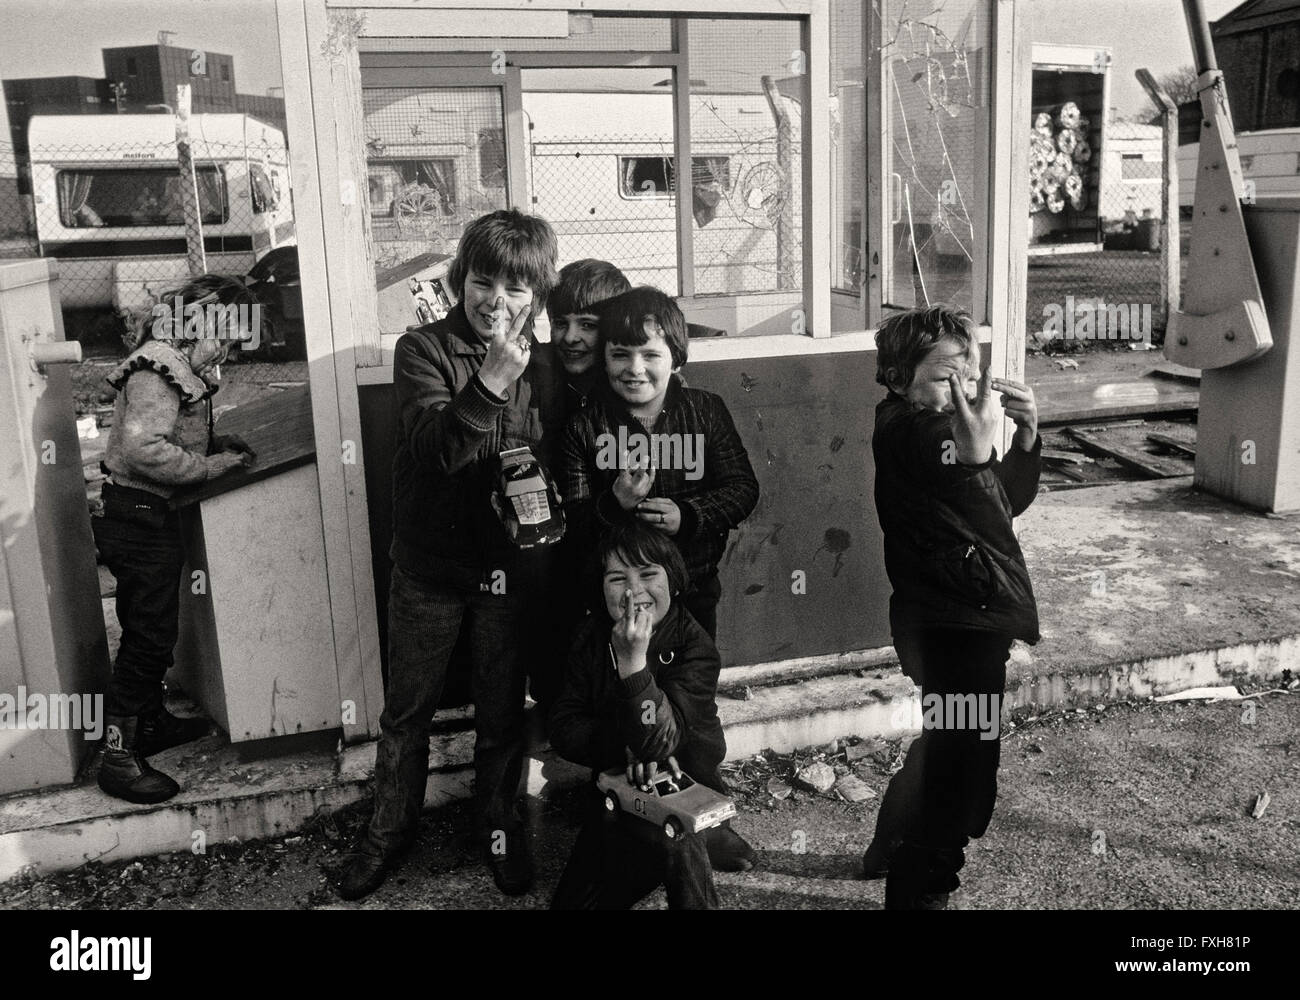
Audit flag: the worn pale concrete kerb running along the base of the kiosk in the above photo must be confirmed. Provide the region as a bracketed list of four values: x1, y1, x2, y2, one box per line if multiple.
[0, 635, 1300, 882]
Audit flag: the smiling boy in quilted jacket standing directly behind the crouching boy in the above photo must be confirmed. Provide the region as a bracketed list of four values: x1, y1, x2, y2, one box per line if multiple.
[560, 286, 758, 871]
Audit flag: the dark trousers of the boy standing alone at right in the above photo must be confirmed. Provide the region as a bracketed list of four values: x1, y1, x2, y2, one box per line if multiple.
[875, 629, 1011, 897]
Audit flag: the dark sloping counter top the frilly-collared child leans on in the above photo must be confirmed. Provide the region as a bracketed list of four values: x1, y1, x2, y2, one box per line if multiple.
[173, 385, 316, 515]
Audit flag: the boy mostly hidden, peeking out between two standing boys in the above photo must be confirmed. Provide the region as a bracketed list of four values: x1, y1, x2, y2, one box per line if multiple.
[528, 259, 632, 719]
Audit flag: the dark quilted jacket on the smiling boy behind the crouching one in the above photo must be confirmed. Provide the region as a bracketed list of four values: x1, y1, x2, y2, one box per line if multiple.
[556, 376, 758, 583]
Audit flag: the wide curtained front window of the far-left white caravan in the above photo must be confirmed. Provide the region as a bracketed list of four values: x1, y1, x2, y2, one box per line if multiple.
[57, 166, 230, 229]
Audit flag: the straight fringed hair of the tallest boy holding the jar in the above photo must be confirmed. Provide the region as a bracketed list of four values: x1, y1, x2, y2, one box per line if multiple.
[447, 208, 559, 312]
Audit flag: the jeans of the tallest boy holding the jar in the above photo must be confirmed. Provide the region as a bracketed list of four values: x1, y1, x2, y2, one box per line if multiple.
[368, 566, 527, 856]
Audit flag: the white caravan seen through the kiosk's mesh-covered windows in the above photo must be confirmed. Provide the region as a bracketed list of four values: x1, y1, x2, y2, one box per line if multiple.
[365, 88, 802, 295]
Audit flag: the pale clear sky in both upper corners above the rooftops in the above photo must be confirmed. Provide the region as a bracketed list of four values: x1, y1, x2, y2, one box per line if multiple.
[0, 0, 1240, 114]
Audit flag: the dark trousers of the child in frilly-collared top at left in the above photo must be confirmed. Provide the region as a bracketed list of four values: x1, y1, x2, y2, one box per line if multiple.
[91, 484, 185, 715]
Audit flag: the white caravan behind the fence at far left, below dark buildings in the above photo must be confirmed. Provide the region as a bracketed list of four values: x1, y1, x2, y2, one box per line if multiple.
[27, 114, 296, 308]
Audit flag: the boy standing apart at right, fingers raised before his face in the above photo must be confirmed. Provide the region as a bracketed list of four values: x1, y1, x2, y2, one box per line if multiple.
[863, 306, 1043, 909]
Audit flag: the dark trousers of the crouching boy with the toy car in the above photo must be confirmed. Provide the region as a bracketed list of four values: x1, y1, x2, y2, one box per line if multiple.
[551, 789, 719, 910]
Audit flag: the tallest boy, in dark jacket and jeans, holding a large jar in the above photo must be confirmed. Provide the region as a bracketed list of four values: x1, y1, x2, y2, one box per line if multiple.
[339, 209, 559, 899]
